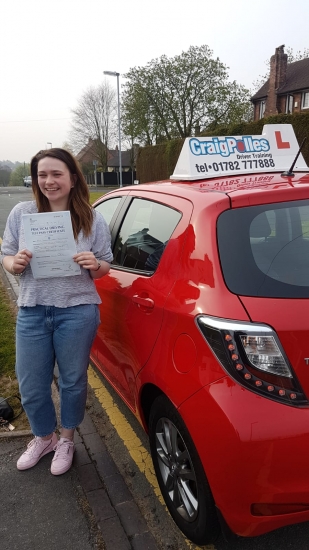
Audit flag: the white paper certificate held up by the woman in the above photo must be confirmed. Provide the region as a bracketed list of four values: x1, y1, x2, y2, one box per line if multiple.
[22, 211, 81, 279]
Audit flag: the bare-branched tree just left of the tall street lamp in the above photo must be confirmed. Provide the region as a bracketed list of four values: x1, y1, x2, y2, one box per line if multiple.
[70, 82, 117, 170]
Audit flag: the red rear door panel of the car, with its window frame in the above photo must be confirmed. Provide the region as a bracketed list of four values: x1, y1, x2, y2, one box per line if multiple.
[94, 193, 192, 410]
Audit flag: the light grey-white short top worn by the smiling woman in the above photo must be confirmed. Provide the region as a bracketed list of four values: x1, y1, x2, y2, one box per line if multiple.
[1, 201, 113, 307]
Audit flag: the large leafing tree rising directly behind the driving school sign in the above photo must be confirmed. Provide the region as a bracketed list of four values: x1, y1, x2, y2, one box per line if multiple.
[122, 46, 250, 145]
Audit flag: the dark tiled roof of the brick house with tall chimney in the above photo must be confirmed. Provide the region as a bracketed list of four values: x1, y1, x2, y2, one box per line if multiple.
[251, 57, 309, 101]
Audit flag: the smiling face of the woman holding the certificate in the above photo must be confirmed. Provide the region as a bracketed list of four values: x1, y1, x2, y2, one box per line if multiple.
[38, 157, 74, 212]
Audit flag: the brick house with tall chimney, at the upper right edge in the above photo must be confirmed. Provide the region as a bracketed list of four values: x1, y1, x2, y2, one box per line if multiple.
[251, 45, 309, 120]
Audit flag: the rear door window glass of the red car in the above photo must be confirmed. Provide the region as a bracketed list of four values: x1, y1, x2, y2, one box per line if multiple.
[112, 198, 181, 273]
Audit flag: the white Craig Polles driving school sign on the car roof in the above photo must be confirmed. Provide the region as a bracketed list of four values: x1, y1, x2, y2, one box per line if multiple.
[171, 124, 308, 180]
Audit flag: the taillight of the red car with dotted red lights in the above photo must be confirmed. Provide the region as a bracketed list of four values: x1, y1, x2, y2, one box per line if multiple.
[196, 315, 308, 407]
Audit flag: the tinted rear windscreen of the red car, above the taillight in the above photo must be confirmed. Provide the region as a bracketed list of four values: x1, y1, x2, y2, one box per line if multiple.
[217, 200, 309, 298]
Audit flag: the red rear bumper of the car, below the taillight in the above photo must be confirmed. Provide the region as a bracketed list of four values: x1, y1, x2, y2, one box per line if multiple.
[179, 377, 309, 536]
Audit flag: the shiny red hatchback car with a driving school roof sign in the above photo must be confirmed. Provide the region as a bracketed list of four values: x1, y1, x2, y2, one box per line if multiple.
[92, 125, 309, 545]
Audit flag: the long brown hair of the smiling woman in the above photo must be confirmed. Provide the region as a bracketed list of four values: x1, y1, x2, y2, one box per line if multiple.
[30, 148, 93, 239]
